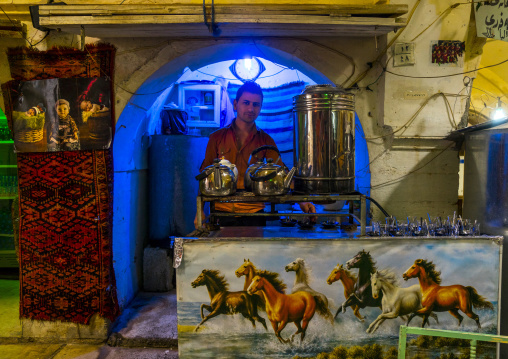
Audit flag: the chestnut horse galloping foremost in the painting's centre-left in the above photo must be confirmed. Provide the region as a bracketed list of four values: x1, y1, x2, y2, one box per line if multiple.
[247, 276, 316, 343]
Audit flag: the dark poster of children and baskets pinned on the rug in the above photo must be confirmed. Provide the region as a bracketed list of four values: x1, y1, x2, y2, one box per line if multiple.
[11, 77, 113, 152]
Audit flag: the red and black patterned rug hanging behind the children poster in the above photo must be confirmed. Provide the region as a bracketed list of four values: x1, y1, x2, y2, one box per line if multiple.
[2, 45, 119, 324]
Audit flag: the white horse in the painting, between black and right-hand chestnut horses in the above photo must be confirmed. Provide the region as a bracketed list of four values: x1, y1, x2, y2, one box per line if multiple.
[367, 269, 438, 333]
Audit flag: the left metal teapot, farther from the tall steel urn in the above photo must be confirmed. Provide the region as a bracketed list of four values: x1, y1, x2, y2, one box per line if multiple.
[196, 158, 238, 197]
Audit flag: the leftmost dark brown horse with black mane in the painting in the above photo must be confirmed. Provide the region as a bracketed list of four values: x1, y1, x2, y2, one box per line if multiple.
[191, 269, 268, 332]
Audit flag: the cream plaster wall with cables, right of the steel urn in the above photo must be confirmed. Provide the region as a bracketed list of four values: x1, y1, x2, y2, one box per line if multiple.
[367, 0, 470, 219]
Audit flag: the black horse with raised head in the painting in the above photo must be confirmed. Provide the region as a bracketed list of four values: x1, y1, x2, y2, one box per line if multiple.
[335, 249, 383, 316]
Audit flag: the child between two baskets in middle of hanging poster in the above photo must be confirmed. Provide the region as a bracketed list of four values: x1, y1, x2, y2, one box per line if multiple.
[50, 99, 80, 151]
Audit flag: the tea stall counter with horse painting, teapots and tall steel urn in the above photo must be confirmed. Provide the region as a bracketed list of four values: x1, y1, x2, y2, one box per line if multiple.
[174, 85, 503, 358]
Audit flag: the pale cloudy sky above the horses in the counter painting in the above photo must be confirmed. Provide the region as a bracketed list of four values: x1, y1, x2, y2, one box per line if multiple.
[177, 237, 500, 304]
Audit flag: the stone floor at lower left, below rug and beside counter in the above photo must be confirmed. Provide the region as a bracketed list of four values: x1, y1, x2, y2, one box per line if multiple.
[0, 279, 178, 359]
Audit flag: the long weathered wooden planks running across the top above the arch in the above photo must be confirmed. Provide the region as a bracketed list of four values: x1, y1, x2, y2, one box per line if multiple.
[35, 2, 407, 37]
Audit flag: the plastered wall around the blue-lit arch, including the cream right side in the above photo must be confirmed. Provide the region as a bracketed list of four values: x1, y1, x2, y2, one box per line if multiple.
[0, 0, 486, 330]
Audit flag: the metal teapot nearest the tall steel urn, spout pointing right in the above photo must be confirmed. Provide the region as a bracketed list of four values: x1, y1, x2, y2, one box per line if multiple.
[249, 158, 296, 196]
